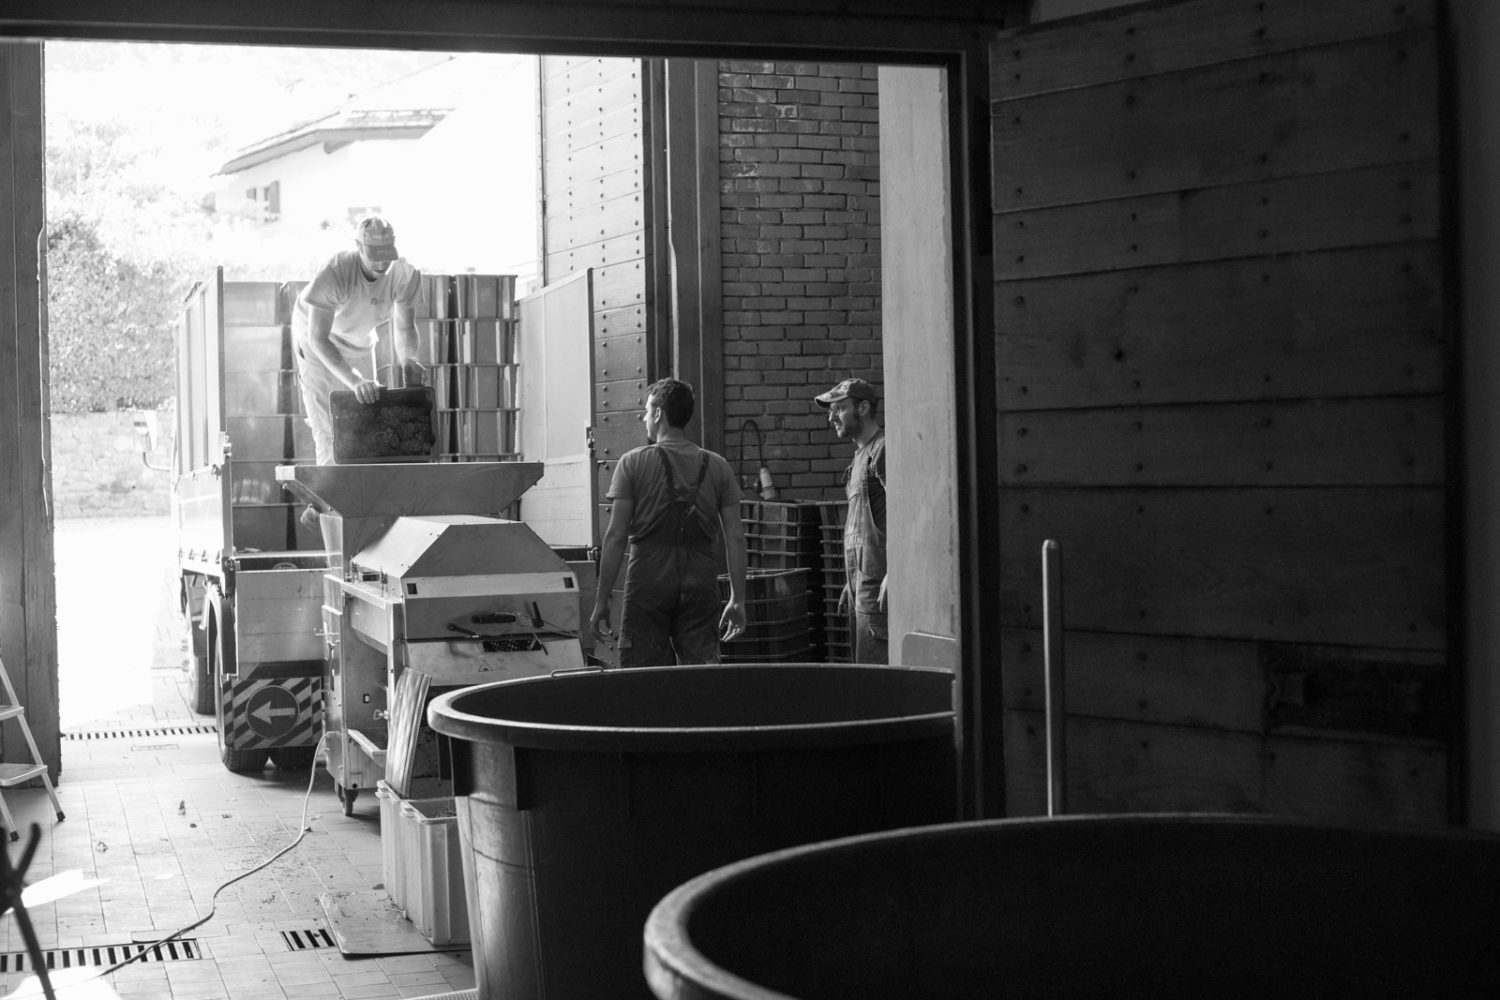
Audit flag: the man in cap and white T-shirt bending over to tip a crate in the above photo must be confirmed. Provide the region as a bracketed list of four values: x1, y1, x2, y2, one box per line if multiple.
[291, 216, 426, 465]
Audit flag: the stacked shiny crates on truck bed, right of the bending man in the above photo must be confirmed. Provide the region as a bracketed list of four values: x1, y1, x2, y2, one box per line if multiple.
[417, 274, 519, 462]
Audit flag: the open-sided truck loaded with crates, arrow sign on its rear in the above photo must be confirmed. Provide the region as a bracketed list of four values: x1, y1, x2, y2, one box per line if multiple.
[173, 267, 599, 779]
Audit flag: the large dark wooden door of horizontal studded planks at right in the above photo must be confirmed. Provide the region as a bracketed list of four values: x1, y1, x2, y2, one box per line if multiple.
[987, 0, 1461, 822]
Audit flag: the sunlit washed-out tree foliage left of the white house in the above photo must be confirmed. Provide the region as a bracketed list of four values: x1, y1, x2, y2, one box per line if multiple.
[45, 42, 440, 412]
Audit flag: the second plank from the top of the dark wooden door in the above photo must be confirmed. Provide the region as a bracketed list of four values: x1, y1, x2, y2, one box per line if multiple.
[993, 31, 1440, 211]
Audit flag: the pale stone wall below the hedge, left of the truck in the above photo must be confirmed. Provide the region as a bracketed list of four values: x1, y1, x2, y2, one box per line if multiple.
[51, 408, 177, 520]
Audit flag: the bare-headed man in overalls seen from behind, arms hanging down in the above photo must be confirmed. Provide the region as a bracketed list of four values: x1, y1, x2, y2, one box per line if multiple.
[590, 378, 746, 667]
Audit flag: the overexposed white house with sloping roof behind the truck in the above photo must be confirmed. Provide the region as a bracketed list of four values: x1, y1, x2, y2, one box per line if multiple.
[213, 54, 540, 288]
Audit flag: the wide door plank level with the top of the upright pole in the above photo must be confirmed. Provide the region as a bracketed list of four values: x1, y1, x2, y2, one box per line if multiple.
[998, 489, 1448, 649]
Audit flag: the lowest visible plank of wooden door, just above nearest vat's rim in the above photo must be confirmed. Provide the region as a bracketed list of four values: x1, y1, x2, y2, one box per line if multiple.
[1005, 712, 1448, 823]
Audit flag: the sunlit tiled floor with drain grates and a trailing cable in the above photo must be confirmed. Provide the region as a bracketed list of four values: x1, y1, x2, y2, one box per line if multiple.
[0, 521, 474, 1000]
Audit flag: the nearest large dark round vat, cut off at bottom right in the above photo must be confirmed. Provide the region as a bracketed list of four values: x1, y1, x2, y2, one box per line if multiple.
[645, 816, 1500, 1000]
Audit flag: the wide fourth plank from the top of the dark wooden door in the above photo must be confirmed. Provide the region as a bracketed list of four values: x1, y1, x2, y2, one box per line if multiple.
[996, 241, 1445, 409]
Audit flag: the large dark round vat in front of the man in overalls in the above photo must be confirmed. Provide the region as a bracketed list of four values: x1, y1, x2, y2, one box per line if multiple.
[428, 664, 956, 1000]
